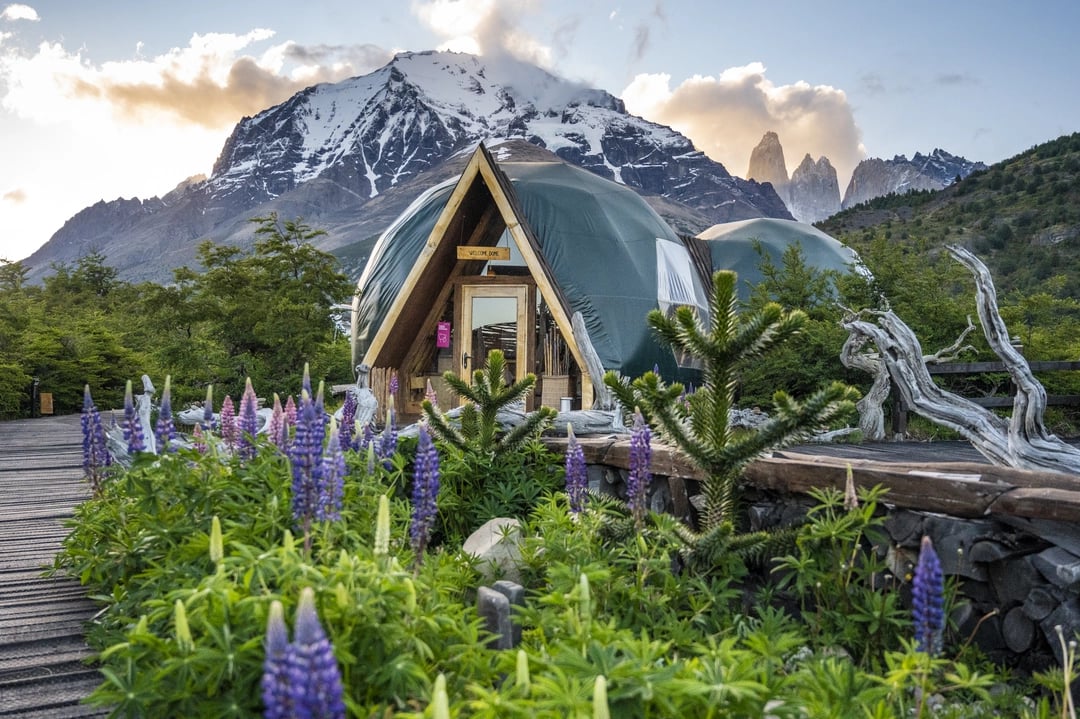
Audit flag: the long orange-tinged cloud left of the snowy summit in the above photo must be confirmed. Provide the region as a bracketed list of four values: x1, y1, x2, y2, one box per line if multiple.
[0, 29, 391, 127]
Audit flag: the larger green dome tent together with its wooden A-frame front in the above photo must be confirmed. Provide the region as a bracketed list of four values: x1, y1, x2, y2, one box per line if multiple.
[353, 146, 707, 405]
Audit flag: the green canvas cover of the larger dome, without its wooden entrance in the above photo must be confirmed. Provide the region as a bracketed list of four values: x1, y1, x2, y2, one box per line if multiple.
[353, 148, 707, 378]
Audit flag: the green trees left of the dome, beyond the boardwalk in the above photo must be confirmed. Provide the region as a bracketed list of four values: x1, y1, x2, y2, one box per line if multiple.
[0, 216, 353, 419]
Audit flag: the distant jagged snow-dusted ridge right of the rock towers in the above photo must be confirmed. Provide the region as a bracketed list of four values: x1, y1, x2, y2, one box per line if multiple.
[842, 148, 986, 209]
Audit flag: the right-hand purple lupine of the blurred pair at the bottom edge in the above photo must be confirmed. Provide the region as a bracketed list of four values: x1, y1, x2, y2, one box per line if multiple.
[286, 586, 345, 719]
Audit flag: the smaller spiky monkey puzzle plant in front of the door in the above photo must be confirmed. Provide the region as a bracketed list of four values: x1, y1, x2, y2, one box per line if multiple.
[423, 350, 555, 456]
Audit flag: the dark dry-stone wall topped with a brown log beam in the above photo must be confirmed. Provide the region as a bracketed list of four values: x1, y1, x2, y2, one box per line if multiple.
[545, 437, 1080, 670]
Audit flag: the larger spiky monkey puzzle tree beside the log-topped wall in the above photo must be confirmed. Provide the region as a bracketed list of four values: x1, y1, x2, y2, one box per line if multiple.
[604, 271, 858, 531]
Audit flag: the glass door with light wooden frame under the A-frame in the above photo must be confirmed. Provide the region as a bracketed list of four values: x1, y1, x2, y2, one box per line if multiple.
[457, 284, 531, 383]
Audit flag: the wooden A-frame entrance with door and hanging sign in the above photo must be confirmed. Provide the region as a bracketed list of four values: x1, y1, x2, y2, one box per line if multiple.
[363, 145, 593, 413]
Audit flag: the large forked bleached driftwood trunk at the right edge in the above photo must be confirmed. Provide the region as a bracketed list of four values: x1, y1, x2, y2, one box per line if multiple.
[843, 246, 1080, 474]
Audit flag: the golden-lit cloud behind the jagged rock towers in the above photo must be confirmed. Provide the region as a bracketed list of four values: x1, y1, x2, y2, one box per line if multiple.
[622, 63, 866, 184]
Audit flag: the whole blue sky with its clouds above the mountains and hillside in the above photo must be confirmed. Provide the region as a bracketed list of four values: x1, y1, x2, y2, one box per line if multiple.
[0, 0, 1080, 261]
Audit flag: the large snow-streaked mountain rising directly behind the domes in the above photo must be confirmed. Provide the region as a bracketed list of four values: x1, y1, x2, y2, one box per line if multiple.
[26, 52, 791, 281]
